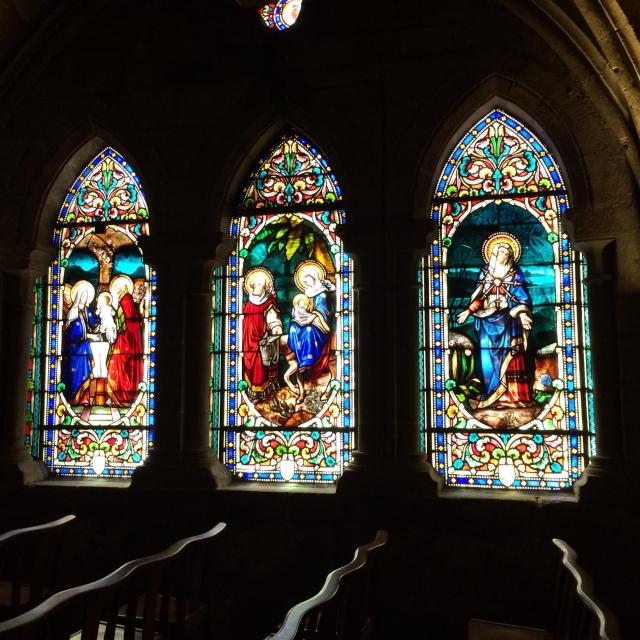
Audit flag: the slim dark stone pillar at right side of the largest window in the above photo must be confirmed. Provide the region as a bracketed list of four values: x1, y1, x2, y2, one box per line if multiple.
[574, 239, 624, 501]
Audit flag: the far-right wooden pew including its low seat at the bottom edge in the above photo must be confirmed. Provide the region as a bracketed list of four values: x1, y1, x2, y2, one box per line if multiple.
[467, 538, 619, 640]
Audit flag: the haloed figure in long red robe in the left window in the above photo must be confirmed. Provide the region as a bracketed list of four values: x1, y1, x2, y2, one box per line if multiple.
[107, 276, 144, 407]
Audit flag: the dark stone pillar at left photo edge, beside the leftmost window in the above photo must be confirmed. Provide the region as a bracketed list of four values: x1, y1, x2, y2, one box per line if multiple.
[0, 251, 49, 487]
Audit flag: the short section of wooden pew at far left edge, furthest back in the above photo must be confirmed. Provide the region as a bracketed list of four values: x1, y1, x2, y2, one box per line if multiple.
[0, 515, 76, 620]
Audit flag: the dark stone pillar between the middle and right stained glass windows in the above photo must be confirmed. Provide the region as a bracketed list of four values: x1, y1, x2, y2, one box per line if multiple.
[338, 219, 439, 496]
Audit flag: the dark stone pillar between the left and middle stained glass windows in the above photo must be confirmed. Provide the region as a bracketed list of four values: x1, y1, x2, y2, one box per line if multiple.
[132, 234, 230, 490]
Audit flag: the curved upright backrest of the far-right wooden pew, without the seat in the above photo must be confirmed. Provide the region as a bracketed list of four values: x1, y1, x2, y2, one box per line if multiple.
[553, 538, 619, 640]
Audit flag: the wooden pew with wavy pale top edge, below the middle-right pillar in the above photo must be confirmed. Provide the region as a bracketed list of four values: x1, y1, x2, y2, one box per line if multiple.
[268, 530, 388, 640]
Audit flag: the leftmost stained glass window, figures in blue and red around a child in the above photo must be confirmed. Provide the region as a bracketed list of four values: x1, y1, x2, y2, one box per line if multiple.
[35, 148, 156, 477]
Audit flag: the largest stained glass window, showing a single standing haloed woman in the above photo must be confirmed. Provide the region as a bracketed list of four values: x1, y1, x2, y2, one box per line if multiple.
[420, 109, 593, 490]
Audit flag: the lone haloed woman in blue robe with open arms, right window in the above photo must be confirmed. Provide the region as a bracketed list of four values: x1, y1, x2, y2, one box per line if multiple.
[457, 232, 533, 409]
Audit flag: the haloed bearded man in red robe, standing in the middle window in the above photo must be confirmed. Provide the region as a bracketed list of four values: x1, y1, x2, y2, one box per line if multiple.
[242, 267, 282, 398]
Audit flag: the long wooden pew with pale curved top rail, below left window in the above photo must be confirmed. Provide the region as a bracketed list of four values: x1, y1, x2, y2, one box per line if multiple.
[0, 522, 226, 640]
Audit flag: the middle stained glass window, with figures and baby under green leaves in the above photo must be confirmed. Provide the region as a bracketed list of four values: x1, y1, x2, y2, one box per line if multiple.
[211, 133, 355, 483]
